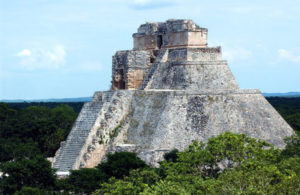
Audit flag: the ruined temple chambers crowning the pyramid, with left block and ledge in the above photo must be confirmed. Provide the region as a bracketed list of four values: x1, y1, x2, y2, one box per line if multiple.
[112, 20, 221, 90]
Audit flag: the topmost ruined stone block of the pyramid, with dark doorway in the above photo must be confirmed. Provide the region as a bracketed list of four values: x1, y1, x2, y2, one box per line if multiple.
[133, 20, 207, 50]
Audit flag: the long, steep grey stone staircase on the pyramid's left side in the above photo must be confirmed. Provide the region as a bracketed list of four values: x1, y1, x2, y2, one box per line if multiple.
[53, 92, 113, 171]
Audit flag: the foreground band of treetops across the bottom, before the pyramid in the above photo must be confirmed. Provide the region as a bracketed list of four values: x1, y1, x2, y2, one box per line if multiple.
[0, 132, 300, 195]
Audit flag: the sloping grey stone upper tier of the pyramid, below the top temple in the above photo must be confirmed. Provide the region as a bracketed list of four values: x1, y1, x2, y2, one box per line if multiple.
[145, 47, 239, 90]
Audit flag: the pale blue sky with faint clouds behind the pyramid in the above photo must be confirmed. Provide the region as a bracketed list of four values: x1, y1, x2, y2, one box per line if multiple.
[0, 0, 300, 99]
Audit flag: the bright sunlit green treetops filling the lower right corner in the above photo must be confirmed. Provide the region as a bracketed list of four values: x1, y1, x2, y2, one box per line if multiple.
[145, 132, 300, 194]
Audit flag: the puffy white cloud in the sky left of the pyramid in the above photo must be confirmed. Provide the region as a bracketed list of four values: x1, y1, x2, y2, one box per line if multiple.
[17, 45, 66, 70]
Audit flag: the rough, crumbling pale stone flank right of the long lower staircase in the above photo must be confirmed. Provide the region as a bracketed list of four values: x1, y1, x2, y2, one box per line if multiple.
[78, 90, 134, 168]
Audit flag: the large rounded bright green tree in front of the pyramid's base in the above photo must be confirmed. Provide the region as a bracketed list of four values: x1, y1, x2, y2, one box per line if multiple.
[156, 132, 280, 194]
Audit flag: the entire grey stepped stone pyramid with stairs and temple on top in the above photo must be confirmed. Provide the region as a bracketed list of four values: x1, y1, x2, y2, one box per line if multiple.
[53, 20, 293, 172]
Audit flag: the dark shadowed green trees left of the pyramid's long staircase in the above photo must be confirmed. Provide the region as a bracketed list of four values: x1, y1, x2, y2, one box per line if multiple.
[0, 103, 77, 194]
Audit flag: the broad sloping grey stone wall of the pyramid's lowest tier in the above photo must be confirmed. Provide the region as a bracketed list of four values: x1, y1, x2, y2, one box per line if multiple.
[103, 89, 293, 166]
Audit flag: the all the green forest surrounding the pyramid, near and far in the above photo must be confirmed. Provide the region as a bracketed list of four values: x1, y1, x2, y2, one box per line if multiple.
[0, 97, 300, 194]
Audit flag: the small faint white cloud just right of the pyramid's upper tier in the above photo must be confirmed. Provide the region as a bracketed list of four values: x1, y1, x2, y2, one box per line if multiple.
[223, 47, 253, 62]
